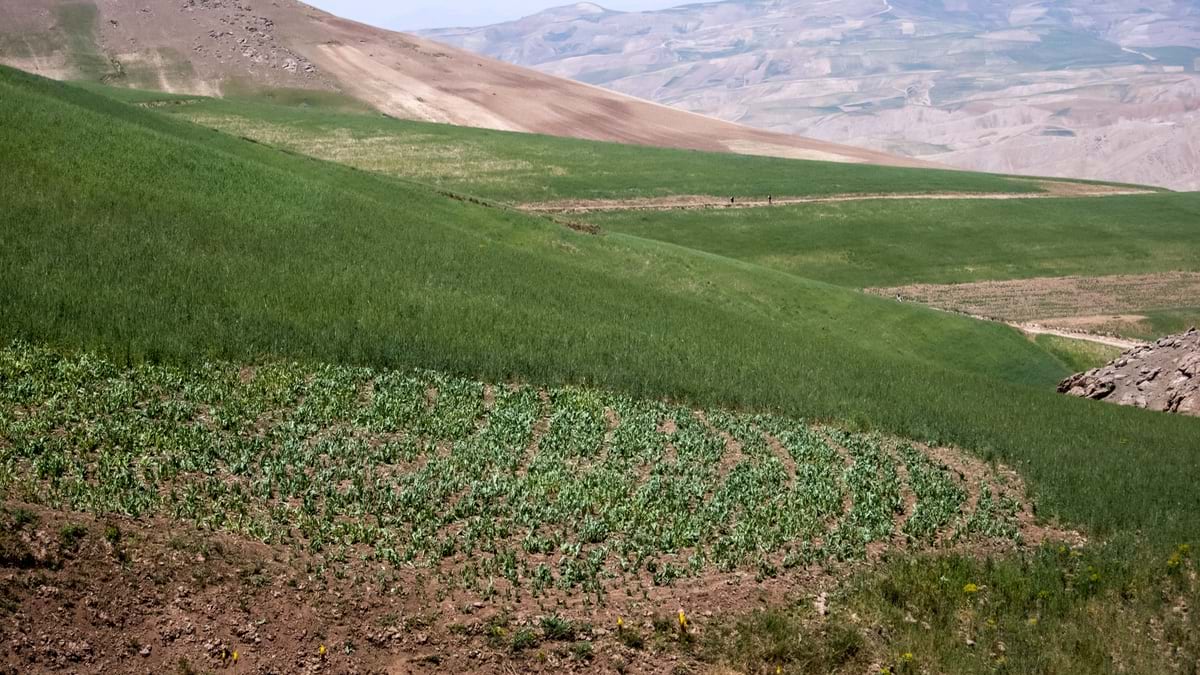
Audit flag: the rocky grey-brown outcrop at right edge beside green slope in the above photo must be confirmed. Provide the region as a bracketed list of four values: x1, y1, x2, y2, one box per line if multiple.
[1058, 328, 1200, 417]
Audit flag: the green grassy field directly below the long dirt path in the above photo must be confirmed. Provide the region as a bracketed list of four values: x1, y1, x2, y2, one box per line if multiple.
[587, 193, 1200, 287]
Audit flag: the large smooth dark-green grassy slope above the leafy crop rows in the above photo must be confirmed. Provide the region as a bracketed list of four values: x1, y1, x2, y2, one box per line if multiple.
[0, 64, 1200, 542]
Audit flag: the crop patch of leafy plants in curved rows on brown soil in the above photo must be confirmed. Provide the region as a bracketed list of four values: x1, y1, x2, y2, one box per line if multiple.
[0, 344, 1032, 598]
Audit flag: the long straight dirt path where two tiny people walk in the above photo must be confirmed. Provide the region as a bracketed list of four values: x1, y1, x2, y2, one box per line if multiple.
[517, 181, 1154, 214]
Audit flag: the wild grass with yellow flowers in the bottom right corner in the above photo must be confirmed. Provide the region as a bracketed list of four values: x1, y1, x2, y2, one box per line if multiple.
[706, 538, 1200, 674]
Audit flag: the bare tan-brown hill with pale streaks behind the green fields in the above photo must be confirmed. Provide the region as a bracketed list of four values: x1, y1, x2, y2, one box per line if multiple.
[0, 0, 922, 166]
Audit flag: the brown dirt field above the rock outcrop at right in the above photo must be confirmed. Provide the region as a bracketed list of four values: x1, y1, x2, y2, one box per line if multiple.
[868, 271, 1200, 330]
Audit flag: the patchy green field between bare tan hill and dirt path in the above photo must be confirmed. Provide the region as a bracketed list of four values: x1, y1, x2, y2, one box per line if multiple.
[87, 90, 1060, 202]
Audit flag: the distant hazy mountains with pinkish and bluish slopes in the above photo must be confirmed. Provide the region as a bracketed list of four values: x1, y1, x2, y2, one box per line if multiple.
[425, 0, 1200, 190]
